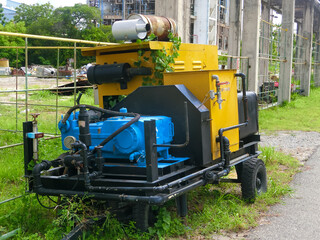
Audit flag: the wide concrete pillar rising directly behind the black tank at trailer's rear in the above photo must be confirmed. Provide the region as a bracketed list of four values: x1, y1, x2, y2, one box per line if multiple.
[242, 0, 261, 93]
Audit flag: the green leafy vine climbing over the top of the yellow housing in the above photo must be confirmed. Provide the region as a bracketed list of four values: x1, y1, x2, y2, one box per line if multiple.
[134, 32, 181, 85]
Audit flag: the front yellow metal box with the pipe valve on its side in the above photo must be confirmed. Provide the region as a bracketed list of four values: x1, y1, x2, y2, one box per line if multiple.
[164, 70, 239, 160]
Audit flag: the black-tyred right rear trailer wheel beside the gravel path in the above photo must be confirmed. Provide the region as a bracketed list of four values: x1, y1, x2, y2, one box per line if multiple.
[241, 158, 267, 203]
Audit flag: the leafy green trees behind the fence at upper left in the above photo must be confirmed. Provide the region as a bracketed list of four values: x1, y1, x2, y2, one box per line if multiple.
[5, 3, 115, 68]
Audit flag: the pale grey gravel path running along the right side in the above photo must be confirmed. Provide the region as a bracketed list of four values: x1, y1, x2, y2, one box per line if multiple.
[205, 131, 320, 240]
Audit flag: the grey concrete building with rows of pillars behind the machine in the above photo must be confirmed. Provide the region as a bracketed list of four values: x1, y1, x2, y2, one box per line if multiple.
[88, 0, 320, 103]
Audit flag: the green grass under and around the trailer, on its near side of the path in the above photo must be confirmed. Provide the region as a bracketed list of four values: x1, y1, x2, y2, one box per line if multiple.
[0, 142, 300, 239]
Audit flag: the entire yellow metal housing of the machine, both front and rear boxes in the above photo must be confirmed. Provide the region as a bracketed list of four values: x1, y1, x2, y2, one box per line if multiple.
[82, 41, 239, 160]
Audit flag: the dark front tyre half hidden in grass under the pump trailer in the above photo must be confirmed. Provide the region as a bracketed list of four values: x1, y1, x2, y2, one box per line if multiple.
[132, 204, 150, 232]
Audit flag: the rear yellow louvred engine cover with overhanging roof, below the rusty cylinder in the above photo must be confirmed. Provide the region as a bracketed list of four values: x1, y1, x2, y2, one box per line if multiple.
[82, 41, 218, 107]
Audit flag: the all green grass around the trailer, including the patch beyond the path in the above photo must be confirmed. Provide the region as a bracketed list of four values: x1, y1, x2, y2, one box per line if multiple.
[0, 85, 320, 239]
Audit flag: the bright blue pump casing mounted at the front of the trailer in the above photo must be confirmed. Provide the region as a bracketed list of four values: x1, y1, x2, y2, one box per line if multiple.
[59, 109, 174, 163]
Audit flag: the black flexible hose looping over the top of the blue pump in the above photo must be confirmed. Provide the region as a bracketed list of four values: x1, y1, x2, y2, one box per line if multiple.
[61, 104, 140, 149]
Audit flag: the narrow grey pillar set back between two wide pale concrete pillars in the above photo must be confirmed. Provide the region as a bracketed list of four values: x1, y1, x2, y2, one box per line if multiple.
[258, 2, 271, 86]
